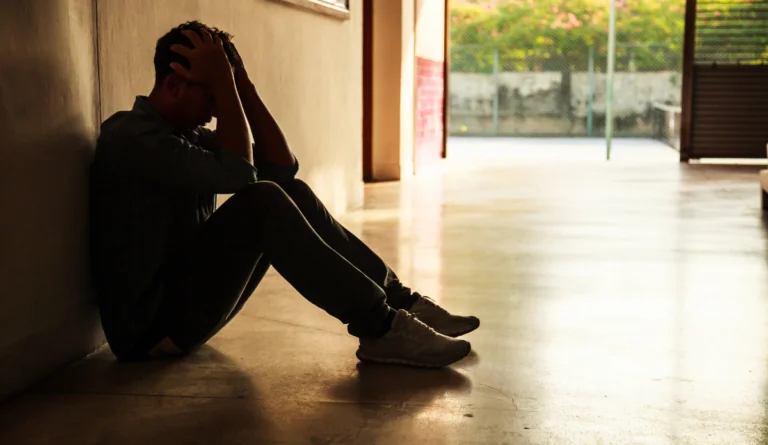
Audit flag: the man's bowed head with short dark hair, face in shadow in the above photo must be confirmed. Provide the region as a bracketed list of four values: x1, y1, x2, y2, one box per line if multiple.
[151, 21, 239, 128]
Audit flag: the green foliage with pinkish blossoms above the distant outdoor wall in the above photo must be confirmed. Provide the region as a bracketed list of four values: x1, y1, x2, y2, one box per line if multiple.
[450, 0, 685, 73]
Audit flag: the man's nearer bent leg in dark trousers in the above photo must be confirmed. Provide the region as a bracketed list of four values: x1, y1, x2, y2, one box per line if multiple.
[158, 182, 394, 350]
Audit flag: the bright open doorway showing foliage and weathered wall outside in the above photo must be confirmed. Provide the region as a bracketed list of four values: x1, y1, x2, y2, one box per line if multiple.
[448, 0, 685, 162]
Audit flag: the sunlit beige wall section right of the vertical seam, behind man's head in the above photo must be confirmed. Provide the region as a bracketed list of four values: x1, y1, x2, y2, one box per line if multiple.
[99, 0, 363, 213]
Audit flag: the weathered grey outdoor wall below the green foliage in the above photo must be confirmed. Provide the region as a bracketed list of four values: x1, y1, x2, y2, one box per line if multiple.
[449, 71, 681, 136]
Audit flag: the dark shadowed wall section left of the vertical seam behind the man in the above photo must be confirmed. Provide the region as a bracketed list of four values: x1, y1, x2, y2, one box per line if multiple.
[0, 0, 102, 399]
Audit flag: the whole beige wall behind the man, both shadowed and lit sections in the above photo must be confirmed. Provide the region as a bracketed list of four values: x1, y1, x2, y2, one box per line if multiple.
[0, 0, 363, 399]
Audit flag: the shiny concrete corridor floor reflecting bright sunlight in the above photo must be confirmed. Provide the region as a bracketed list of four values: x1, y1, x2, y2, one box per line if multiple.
[0, 139, 768, 445]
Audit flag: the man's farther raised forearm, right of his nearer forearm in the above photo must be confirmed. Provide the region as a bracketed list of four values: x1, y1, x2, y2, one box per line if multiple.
[235, 67, 296, 167]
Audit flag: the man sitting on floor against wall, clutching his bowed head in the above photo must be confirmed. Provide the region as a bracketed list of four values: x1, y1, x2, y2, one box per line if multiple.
[87, 22, 480, 367]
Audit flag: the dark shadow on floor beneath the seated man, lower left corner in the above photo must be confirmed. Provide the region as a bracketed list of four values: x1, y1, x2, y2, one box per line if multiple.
[0, 346, 272, 445]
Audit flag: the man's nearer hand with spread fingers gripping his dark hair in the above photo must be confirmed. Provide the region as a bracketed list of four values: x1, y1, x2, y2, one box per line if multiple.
[171, 29, 232, 88]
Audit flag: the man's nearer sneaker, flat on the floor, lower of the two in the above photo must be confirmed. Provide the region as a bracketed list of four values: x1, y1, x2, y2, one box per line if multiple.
[357, 309, 472, 368]
